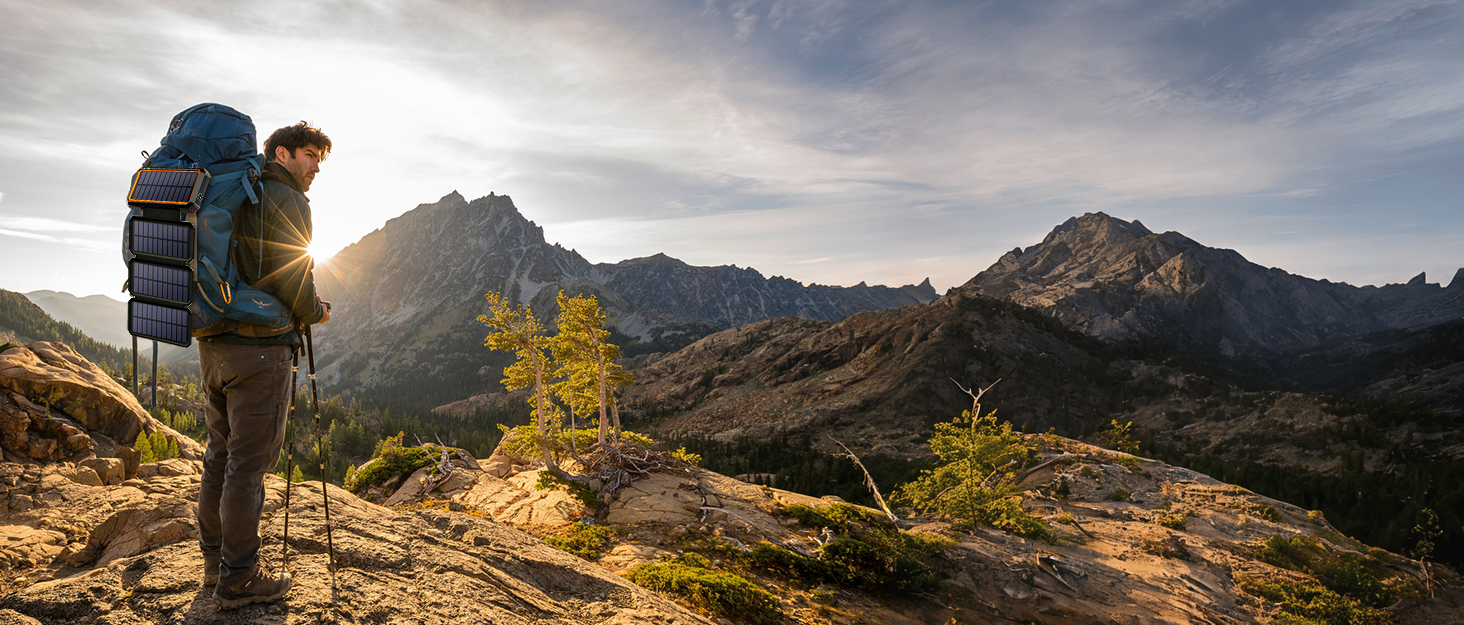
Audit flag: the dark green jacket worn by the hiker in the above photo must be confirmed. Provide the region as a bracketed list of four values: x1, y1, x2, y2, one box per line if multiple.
[214, 161, 325, 345]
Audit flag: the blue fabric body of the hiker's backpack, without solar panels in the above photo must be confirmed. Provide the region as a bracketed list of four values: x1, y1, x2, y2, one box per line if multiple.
[123, 104, 294, 337]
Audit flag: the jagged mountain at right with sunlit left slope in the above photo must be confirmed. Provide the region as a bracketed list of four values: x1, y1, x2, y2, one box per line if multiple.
[960, 212, 1464, 360]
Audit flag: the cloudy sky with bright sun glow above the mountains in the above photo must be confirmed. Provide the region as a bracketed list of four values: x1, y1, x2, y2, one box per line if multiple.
[0, 0, 1464, 299]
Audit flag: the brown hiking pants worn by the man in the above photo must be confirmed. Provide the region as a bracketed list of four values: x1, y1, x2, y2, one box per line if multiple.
[198, 338, 294, 584]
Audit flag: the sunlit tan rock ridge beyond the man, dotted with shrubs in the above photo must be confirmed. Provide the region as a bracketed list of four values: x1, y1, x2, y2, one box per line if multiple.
[366, 439, 1464, 625]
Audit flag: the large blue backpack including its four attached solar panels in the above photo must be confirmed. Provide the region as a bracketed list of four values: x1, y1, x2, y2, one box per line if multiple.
[122, 104, 293, 347]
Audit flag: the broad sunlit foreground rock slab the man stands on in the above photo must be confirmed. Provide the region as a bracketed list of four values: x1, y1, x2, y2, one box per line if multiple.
[0, 476, 710, 625]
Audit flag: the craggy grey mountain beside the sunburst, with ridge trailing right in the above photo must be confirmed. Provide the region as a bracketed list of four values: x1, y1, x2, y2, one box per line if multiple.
[315, 192, 937, 405]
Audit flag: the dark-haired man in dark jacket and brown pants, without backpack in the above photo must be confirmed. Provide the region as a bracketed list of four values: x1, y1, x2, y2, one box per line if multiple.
[198, 121, 331, 609]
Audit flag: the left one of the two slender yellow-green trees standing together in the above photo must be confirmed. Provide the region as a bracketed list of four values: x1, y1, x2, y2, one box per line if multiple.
[477, 293, 558, 467]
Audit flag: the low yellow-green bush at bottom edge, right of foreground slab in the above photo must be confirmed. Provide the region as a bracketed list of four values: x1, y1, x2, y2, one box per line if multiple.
[625, 553, 782, 625]
